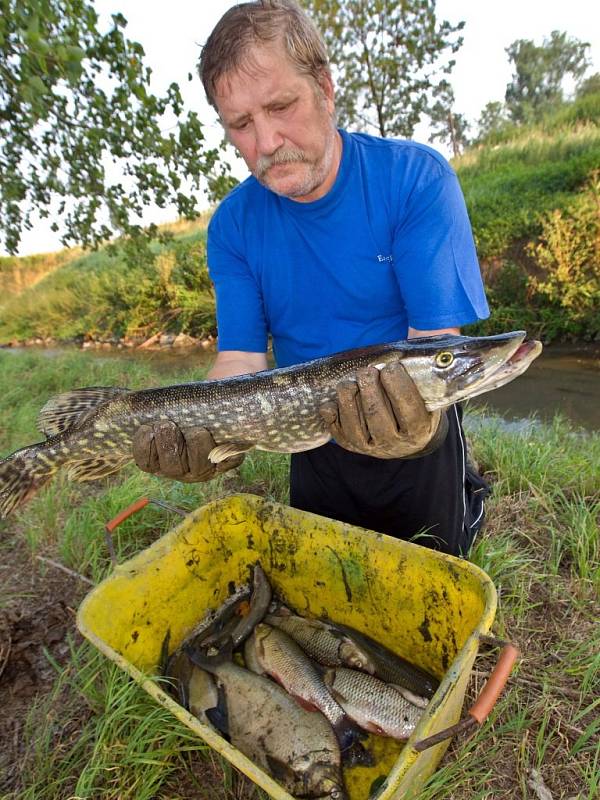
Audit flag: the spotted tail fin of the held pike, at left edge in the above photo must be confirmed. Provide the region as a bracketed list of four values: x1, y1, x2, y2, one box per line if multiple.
[0, 442, 60, 519]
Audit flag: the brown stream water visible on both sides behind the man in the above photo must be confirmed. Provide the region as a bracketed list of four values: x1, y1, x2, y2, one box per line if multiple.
[2, 345, 600, 430]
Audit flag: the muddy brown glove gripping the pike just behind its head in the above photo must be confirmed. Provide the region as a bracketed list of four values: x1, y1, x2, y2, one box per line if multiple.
[320, 364, 448, 458]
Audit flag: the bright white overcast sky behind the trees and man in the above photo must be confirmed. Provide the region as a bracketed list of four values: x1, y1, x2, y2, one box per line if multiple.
[9, 0, 600, 255]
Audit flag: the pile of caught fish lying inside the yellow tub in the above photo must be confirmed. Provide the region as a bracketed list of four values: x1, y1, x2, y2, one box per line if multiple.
[161, 562, 438, 800]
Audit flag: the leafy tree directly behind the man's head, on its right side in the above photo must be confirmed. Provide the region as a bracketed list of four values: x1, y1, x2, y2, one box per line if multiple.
[303, 0, 464, 136]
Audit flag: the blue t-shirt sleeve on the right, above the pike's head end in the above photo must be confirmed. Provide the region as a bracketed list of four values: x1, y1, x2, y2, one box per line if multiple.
[394, 167, 489, 330]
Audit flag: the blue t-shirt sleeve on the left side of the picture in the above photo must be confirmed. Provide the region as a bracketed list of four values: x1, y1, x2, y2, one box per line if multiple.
[207, 205, 267, 353]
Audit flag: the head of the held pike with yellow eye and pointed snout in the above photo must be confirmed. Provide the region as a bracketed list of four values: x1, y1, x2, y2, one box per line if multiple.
[375, 331, 542, 411]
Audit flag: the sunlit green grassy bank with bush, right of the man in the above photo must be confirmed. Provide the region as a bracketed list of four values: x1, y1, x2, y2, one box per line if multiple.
[453, 95, 600, 342]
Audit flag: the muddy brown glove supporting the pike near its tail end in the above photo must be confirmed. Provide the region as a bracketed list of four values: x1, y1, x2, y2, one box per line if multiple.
[133, 420, 244, 483]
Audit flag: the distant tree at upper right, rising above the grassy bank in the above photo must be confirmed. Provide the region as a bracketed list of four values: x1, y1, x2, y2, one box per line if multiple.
[505, 31, 590, 123]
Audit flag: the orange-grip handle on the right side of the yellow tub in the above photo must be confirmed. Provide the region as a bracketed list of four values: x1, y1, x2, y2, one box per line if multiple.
[414, 636, 519, 753]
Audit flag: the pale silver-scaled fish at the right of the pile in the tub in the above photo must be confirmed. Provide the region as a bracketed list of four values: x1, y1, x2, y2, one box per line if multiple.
[324, 667, 423, 740]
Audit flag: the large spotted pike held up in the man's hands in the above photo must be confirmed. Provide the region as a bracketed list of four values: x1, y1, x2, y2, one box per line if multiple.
[0, 331, 542, 518]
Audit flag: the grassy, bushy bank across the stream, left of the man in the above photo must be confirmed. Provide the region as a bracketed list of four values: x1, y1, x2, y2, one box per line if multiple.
[0, 229, 215, 342]
